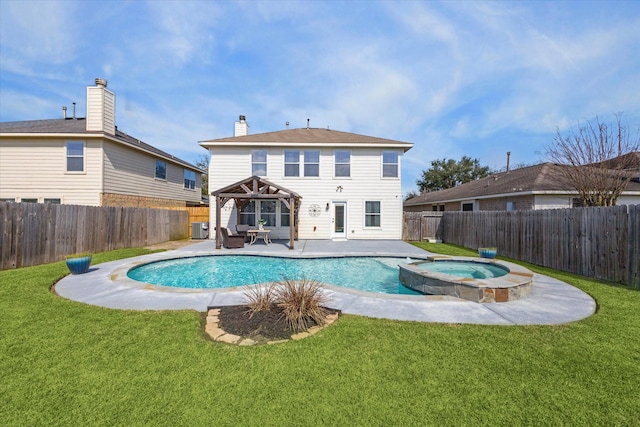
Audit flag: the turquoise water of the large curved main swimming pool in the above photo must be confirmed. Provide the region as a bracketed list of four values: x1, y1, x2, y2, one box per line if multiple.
[127, 255, 421, 295]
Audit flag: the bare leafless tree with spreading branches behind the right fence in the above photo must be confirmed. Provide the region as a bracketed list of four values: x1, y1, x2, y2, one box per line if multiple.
[546, 114, 640, 206]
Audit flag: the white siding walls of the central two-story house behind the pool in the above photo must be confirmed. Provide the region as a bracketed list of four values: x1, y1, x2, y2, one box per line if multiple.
[209, 144, 403, 239]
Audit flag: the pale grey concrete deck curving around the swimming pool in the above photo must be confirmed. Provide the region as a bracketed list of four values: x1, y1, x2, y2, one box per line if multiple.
[55, 240, 596, 325]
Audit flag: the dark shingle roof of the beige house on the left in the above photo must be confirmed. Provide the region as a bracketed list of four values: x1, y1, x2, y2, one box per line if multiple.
[0, 118, 203, 173]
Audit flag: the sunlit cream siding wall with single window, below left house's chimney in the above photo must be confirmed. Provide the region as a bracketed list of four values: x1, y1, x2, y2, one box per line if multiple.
[0, 138, 102, 206]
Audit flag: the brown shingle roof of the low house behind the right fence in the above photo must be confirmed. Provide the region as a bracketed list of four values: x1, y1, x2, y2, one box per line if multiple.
[404, 163, 640, 206]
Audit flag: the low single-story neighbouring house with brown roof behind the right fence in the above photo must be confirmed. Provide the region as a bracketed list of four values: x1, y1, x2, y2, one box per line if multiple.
[404, 163, 640, 212]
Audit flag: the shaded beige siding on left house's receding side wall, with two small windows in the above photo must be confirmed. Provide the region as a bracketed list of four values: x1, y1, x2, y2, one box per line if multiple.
[104, 141, 202, 206]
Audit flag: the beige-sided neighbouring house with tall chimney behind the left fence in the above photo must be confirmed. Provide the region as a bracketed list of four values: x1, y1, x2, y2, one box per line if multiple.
[0, 79, 202, 207]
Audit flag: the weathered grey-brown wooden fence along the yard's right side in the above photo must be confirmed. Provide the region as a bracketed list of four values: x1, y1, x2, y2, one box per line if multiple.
[403, 205, 640, 289]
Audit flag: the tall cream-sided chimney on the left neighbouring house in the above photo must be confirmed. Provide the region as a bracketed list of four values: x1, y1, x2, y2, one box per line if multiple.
[87, 78, 116, 135]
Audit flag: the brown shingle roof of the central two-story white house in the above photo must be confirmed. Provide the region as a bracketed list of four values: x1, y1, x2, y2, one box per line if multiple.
[200, 128, 413, 151]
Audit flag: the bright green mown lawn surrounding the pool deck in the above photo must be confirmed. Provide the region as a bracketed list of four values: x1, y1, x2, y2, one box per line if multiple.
[0, 244, 640, 426]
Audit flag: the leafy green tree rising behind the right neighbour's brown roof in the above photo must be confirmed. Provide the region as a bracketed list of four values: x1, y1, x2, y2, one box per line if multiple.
[416, 156, 491, 193]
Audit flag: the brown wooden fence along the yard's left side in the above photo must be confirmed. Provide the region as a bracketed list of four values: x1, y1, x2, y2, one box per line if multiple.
[0, 202, 188, 270]
